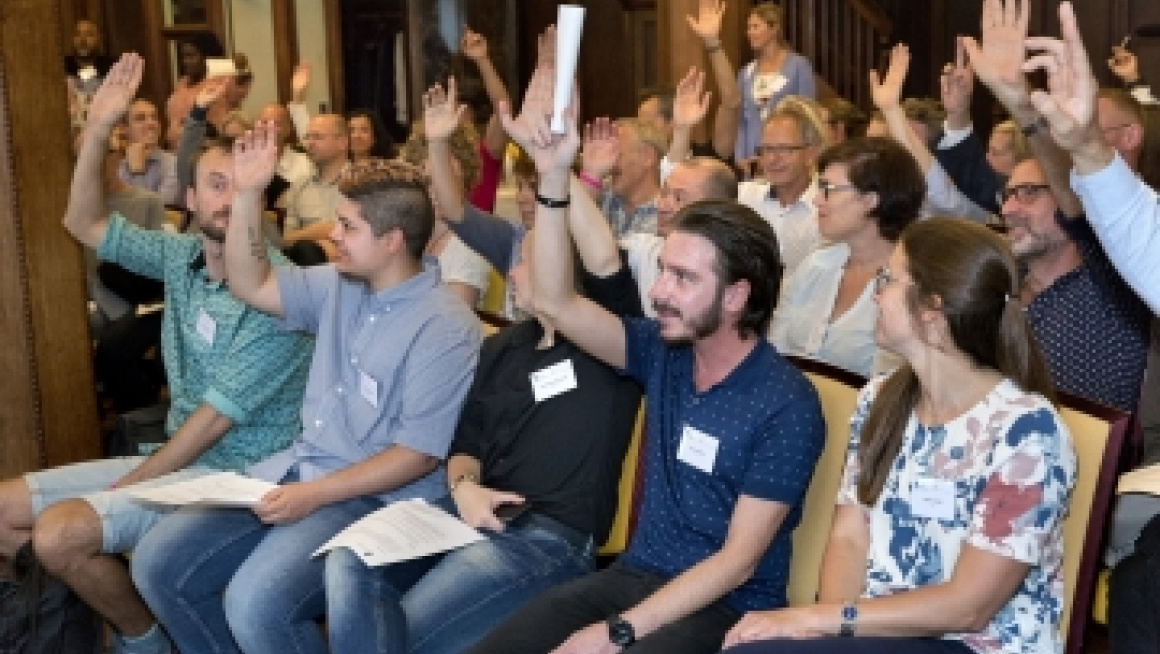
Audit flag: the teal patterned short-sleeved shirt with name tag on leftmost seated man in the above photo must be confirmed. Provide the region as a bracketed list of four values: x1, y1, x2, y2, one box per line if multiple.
[96, 212, 312, 472]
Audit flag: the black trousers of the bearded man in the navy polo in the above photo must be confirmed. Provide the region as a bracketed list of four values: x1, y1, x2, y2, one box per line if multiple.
[467, 562, 741, 654]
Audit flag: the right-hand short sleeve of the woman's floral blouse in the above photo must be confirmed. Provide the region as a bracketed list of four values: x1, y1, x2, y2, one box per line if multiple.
[967, 408, 1075, 565]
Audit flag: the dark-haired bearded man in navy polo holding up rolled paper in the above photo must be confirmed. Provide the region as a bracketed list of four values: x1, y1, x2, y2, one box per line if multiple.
[469, 61, 825, 654]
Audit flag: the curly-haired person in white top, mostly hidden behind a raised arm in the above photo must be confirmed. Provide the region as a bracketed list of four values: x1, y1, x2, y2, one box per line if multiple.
[400, 114, 491, 307]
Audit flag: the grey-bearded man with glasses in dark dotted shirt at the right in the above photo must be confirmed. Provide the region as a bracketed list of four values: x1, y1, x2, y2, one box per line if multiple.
[1001, 154, 1150, 412]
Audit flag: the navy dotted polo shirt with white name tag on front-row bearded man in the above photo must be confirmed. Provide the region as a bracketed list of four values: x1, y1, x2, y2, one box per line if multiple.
[621, 318, 826, 612]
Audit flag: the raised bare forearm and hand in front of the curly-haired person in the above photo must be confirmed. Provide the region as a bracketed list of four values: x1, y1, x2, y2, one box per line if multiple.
[423, 77, 467, 223]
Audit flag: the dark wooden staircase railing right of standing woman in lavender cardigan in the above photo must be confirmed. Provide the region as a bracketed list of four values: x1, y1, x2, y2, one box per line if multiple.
[781, 0, 893, 109]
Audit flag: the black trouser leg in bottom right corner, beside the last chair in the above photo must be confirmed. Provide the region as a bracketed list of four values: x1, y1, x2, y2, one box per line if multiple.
[1108, 515, 1160, 654]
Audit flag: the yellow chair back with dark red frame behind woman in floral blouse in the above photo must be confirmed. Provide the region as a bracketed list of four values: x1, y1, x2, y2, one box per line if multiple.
[1059, 395, 1131, 654]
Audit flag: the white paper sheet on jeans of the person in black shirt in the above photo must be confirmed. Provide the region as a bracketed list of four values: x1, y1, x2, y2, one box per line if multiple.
[313, 500, 484, 567]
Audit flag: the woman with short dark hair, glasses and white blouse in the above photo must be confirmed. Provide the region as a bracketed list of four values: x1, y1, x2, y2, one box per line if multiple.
[769, 137, 926, 376]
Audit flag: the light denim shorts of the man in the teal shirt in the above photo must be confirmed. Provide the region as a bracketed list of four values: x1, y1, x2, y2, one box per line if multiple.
[24, 457, 219, 554]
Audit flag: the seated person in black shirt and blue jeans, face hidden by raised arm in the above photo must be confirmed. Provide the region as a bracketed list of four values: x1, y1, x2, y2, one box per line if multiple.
[326, 234, 640, 654]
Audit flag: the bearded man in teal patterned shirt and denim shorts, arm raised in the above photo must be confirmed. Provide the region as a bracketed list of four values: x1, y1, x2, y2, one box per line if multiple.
[0, 55, 310, 654]
